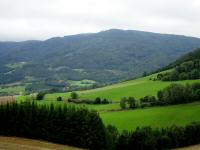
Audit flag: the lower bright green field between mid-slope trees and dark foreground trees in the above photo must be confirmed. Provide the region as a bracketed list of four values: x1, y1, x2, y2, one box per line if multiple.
[100, 102, 200, 131]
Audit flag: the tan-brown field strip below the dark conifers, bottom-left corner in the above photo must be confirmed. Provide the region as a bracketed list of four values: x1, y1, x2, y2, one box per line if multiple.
[0, 136, 81, 150]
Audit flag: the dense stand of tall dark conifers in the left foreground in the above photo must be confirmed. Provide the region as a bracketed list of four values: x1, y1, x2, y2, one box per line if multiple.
[0, 103, 106, 149]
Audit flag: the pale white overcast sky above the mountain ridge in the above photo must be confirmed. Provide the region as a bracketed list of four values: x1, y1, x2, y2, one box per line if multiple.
[0, 0, 200, 41]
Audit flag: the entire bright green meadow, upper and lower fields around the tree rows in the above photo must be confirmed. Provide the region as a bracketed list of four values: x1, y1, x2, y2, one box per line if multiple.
[17, 74, 200, 131]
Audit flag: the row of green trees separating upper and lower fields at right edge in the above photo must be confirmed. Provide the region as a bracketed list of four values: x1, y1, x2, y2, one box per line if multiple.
[120, 83, 200, 109]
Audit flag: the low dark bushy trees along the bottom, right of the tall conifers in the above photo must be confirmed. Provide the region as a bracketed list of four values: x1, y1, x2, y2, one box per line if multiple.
[107, 123, 200, 150]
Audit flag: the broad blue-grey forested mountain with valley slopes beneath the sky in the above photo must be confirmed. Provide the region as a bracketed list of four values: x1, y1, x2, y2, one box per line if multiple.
[0, 29, 200, 91]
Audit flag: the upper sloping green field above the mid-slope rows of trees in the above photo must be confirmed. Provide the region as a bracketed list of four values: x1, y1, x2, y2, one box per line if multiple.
[41, 75, 200, 101]
